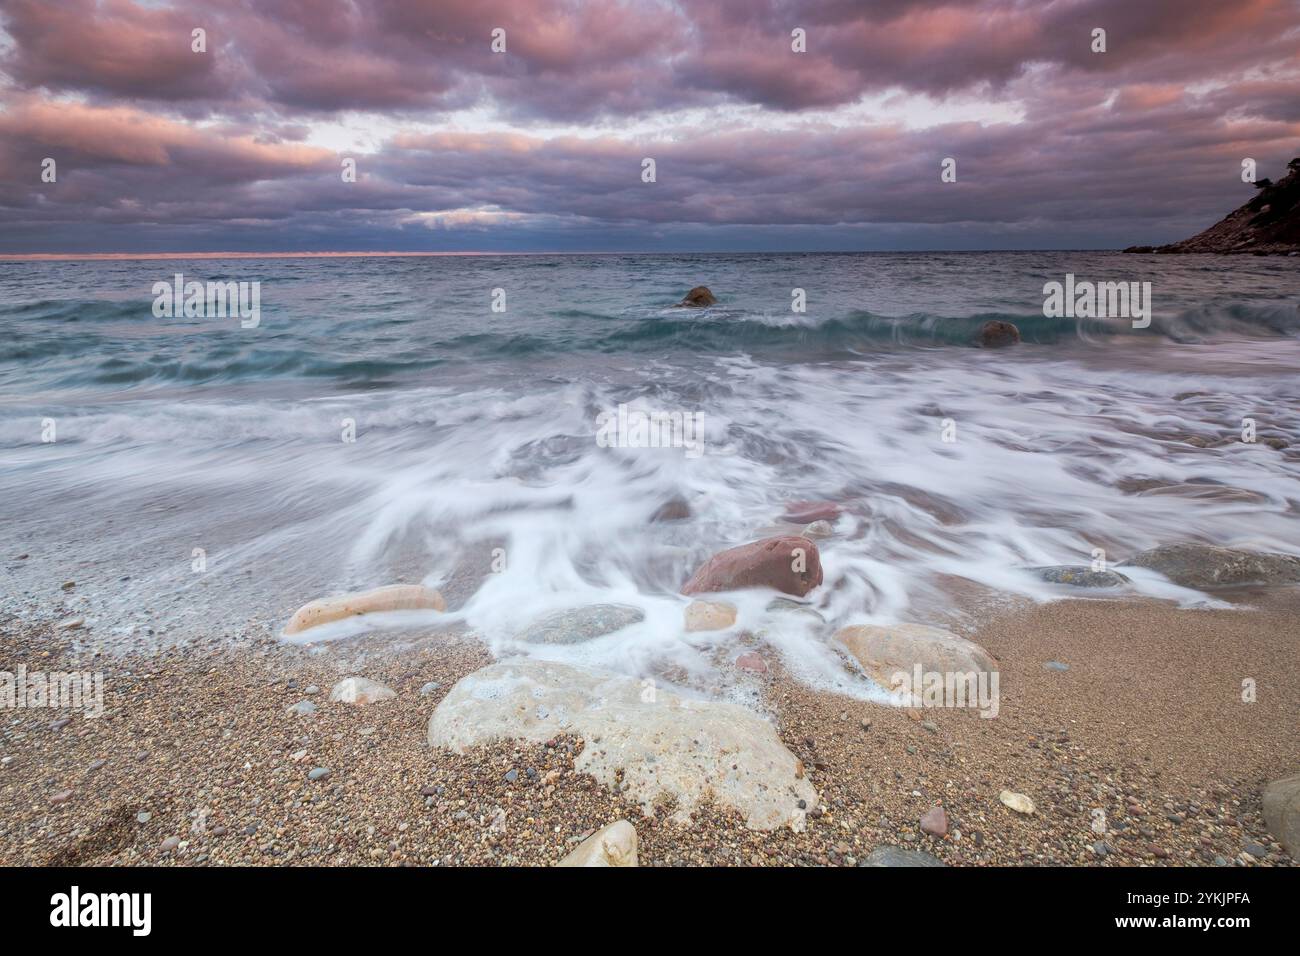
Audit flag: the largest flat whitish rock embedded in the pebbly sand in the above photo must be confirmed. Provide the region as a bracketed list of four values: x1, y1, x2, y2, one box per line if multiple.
[428, 659, 818, 830]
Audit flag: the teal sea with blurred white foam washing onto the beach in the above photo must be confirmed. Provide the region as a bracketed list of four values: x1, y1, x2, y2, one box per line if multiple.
[0, 252, 1300, 687]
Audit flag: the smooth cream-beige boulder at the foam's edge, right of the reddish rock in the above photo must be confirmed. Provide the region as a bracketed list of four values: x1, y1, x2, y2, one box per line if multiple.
[835, 624, 997, 706]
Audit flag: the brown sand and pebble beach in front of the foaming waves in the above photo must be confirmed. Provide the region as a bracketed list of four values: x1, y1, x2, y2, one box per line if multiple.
[0, 588, 1300, 866]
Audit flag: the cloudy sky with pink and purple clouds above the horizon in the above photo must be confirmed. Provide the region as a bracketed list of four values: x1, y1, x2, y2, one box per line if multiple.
[0, 0, 1300, 254]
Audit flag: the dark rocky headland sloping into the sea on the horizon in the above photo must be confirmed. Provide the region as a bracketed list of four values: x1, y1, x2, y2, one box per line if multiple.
[1125, 157, 1300, 255]
